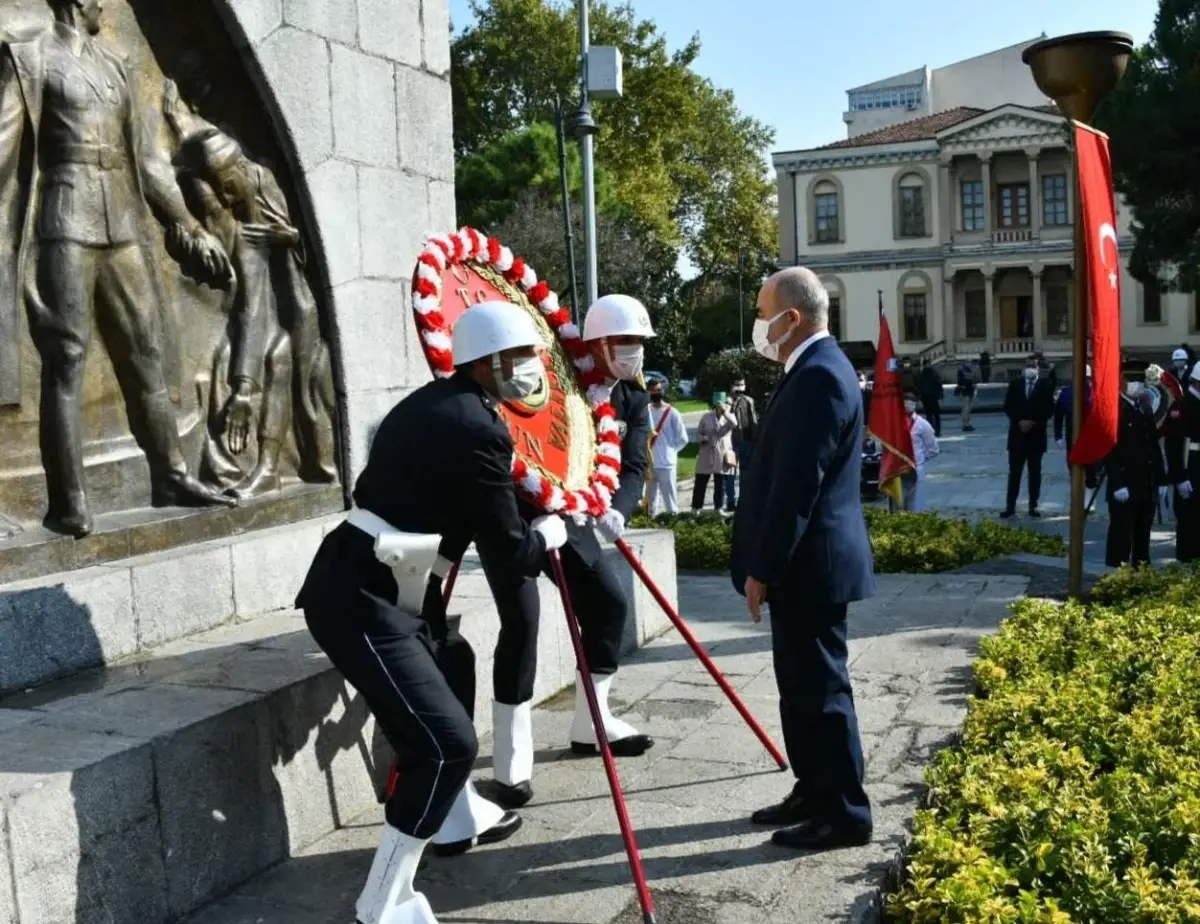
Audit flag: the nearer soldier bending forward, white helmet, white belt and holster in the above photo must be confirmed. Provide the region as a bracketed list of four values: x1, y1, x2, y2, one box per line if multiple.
[296, 302, 566, 924]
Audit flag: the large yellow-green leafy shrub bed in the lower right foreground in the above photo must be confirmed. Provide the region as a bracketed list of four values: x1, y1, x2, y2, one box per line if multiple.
[888, 556, 1200, 924]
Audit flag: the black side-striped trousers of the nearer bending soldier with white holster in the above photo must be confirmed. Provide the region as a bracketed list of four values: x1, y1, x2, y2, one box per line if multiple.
[304, 524, 479, 840]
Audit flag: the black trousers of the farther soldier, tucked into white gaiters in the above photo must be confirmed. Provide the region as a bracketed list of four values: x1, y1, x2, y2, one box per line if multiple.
[480, 536, 629, 706]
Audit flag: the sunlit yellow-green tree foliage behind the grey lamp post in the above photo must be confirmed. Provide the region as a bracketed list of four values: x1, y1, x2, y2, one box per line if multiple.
[451, 0, 776, 280]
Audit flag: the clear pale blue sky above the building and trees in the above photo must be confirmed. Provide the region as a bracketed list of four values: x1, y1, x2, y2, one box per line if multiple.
[450, 0, 1158, 150]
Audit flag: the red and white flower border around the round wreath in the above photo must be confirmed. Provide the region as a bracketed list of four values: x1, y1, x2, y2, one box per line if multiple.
[413, 228, 620, 517]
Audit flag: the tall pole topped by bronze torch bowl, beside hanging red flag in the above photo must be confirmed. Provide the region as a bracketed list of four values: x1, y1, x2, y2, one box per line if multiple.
[1021, 32, 1133, 600]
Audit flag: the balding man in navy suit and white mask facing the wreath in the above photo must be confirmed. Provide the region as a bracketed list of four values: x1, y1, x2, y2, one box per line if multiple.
[731, 266, 875, 850]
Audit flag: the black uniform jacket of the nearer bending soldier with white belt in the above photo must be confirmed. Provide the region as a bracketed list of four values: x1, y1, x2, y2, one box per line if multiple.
[296, 373, 546, 608]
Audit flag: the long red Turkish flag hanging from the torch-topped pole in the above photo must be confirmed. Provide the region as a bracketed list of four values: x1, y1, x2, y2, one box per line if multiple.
[1068, 122, 1121, 466]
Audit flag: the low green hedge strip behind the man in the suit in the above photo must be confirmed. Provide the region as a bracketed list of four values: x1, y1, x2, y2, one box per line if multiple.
[632, 508, 1066, 574]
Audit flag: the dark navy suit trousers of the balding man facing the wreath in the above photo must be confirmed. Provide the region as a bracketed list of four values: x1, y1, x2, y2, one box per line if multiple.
[767, 588, 871, 826]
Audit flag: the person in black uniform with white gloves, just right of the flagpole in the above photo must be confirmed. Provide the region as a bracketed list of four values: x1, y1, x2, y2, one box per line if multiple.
[1104, 382, 1166, 568]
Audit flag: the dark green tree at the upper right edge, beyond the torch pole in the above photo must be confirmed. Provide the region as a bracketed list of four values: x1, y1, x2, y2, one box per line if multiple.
[1097, 0, 1200, 292]
